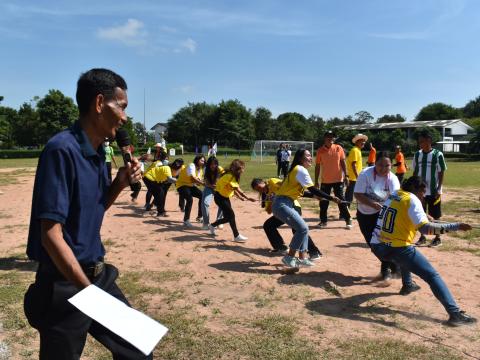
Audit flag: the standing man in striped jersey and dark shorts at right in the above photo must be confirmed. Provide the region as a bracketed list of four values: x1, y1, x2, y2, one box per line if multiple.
[412, 131, 447, 247]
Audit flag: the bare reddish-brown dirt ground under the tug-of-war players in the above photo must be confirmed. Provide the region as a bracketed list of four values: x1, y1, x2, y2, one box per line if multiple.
[0, 169, 480, 359]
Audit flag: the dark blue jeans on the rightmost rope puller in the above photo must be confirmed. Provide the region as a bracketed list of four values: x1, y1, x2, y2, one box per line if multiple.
[371, 244, 460, 314]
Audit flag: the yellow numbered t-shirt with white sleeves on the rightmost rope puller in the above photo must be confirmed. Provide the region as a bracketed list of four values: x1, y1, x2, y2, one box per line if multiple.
[370, 190, 428, 247]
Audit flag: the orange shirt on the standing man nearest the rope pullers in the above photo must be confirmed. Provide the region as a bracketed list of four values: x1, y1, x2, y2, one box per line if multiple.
[315, 144, 345, 184]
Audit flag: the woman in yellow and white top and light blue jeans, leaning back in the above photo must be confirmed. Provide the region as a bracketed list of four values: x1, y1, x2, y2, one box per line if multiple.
[272, 149, 342, 268]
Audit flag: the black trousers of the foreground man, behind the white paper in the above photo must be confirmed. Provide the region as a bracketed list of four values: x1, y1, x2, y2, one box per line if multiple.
[24, 264, 153, 360]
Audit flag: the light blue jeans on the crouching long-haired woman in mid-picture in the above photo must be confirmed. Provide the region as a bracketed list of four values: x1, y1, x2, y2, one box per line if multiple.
[272, 196, 308, 252]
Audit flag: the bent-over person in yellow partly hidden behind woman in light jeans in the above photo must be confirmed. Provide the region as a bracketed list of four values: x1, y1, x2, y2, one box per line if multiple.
[251, 178, 322, 261]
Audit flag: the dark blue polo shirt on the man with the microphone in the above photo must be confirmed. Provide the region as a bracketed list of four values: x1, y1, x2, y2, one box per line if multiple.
[27, 121, 110, 263]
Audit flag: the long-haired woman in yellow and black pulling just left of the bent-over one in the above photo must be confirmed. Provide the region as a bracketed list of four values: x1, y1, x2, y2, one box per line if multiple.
[208, 159, 256, 241]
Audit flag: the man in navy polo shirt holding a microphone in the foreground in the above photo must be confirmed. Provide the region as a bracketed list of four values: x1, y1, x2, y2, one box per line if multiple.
[24, 69, 152, 360]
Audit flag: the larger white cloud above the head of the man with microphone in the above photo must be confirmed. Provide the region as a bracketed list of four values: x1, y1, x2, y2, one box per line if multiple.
[97, 19, 148, 46]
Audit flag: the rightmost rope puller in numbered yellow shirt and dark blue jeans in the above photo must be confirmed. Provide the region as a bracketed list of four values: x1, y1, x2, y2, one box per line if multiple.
[370, 176, 477, 326]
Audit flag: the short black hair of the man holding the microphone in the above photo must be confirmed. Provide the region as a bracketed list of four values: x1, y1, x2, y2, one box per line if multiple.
[76, 69, 127, 115]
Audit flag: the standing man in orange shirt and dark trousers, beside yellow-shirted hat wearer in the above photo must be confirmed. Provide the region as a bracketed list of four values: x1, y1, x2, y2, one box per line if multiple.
[315, 130, 352, 228]
